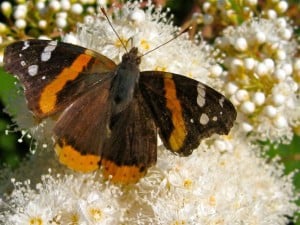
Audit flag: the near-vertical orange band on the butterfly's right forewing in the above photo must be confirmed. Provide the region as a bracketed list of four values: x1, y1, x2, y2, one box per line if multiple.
[164, 74, 186, 151]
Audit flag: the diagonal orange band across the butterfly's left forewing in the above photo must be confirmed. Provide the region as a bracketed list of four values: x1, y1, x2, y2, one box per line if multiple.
[39, 54, 93, 113]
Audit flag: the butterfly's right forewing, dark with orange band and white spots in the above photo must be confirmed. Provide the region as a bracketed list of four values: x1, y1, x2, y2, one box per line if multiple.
[139, 71, 236, 155]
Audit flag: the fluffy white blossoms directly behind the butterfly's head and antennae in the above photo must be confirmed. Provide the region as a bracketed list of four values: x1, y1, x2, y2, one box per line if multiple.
[70, 2, 216, 87]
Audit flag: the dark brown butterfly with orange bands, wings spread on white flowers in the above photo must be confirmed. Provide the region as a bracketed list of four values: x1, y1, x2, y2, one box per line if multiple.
[4, 39, 236, 184]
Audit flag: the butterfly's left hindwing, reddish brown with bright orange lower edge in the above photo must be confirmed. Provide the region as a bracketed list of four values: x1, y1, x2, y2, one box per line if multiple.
[54, 79, 111, 172]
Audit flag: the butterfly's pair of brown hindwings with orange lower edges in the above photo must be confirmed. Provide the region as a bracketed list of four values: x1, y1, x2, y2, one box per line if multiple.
[54, 79, 157, 184]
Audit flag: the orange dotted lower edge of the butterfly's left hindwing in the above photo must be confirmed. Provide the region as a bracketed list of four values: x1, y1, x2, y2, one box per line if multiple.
[55, 141, 100, 172]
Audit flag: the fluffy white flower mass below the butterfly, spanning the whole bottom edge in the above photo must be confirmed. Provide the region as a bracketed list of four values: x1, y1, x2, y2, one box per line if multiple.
[0, 140, 297, 225]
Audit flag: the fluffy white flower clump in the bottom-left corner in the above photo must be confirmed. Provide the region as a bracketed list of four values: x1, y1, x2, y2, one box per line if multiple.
[1, 168, 121, 225]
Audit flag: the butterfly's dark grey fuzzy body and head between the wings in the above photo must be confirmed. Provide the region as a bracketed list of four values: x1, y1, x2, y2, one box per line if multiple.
[111, 48, 141, 114]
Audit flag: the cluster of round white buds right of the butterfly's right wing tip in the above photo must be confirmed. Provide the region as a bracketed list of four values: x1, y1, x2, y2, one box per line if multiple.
[216, 18, 300, 143]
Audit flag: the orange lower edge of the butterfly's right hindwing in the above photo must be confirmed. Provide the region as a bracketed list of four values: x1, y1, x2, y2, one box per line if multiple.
[101, 160, 146, 184]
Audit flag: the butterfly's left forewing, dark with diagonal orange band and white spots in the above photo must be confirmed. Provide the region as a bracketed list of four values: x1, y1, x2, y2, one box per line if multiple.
[4, 39, 116, 118]
